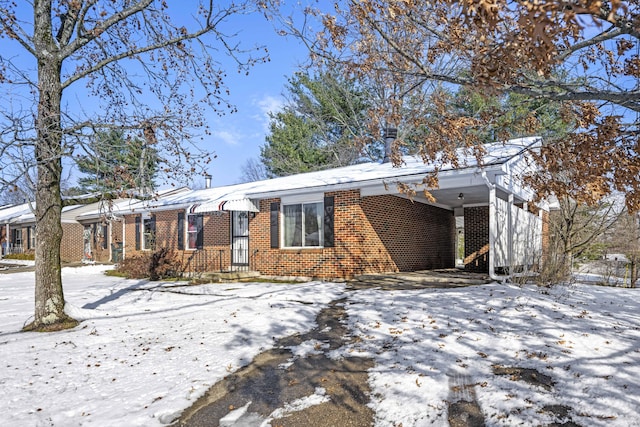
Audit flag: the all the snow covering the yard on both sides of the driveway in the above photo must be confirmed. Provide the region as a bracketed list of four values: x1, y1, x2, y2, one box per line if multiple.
[0, 266, 640, 427]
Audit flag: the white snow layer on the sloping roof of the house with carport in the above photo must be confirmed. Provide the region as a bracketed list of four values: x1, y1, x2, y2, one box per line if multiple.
[132, 137, 540, 212]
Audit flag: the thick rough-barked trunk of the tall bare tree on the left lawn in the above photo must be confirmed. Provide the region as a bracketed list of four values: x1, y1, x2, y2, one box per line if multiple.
[25, 2, 77, 330]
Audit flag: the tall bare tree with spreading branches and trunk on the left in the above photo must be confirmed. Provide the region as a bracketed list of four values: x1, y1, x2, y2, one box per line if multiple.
[0, 0, 267, 329]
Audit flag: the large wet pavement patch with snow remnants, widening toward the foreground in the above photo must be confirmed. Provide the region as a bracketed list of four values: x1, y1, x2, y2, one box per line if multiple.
[173, 299, 374, 427]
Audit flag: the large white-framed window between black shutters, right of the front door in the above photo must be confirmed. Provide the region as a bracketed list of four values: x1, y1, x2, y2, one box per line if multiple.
[282, 202, 323, 248]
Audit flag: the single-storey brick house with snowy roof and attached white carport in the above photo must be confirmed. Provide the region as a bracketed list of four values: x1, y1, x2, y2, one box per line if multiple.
[122, 138, 545, 278]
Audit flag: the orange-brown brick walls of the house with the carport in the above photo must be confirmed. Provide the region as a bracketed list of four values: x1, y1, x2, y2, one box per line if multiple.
[125, 190, 464, 279]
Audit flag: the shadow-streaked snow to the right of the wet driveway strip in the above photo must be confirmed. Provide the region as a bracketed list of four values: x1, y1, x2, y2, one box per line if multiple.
[338, 284, 640, 427]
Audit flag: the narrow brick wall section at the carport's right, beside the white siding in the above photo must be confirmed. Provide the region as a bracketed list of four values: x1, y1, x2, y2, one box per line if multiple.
[464, 206, 489, 273]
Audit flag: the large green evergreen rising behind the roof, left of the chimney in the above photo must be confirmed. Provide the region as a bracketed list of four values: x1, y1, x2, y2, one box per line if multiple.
[260, 72, 370, 177]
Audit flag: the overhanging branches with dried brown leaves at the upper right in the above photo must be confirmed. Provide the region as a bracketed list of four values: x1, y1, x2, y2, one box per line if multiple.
[284, 0, 640, 211]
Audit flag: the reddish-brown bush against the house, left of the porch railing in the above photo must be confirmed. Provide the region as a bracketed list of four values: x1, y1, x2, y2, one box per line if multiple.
[117, 248, 182, 280]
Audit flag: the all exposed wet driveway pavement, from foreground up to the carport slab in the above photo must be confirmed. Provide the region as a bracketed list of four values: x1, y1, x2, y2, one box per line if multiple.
[172, 269, 491, 427]
